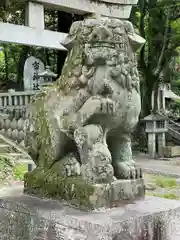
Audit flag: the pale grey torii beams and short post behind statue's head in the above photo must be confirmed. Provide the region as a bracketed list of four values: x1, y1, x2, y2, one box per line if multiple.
[0, 0, 138, 50]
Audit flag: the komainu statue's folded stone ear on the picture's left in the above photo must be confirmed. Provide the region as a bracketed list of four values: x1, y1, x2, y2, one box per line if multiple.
[61, 21, 82, 51]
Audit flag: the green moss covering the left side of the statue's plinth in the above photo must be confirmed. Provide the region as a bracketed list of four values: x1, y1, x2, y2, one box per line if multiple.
[24, 167, 94, 208]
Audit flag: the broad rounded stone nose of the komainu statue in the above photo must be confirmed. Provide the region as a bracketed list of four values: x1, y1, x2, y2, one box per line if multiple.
[92, 26, 112, 41]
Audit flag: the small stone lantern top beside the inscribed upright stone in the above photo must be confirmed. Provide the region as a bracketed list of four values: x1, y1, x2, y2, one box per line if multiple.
[38, 66, 58, 89]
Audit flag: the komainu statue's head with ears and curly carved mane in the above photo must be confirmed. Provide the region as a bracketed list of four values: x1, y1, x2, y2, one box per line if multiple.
[59, 18, 144, 94]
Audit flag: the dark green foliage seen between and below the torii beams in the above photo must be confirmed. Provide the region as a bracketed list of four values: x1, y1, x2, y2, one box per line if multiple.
[0, 1, 80, 90]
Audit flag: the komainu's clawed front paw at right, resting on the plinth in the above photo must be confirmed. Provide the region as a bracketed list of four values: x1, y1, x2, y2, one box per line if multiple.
[114, 160, 142, 179]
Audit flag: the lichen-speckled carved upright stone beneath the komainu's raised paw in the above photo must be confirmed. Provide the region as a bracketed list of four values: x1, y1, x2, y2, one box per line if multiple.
[74, 124, 114, 183]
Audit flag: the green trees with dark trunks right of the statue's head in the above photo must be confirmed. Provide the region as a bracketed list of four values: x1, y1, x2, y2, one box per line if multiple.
[132, 0, 180, 116]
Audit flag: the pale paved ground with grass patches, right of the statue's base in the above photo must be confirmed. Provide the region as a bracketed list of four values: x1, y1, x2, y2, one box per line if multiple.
[134, 152, 180, 199]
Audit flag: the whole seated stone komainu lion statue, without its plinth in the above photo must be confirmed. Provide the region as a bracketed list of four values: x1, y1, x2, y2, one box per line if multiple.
[26, 18, 144, 208]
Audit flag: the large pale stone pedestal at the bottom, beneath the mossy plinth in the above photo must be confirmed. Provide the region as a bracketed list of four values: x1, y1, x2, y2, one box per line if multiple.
[0, 186, 180, 240]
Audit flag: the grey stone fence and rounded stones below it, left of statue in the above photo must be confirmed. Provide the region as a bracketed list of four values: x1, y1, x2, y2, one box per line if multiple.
[0, 90, 38, 145]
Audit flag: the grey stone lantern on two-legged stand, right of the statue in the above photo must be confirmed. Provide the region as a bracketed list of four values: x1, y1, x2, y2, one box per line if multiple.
[144, 114, 168, 158]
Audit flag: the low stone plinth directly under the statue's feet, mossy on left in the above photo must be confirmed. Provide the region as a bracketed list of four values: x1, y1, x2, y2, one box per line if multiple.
[24, 168, 145, 209]
